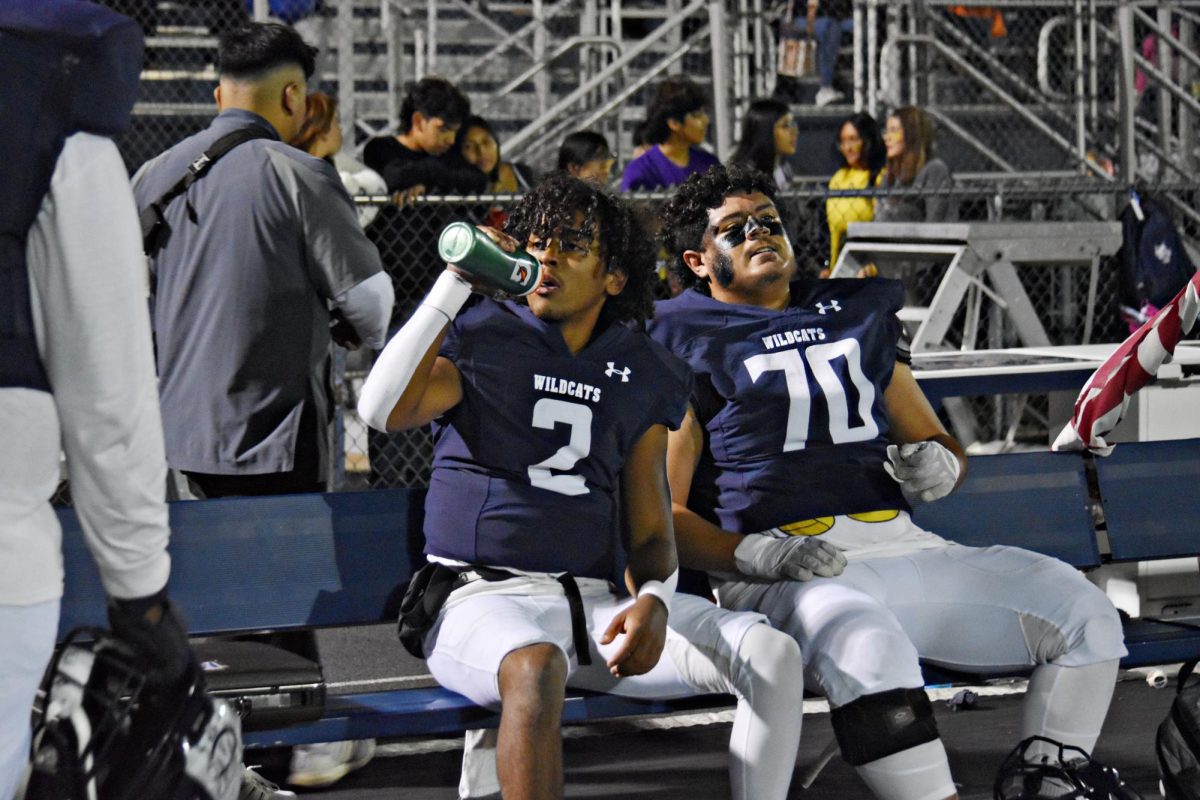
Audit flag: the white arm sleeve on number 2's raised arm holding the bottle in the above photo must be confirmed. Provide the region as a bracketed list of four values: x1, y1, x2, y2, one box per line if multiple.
[359, 272, 470, 431]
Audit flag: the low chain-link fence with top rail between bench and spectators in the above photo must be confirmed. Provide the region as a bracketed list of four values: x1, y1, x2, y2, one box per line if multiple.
[334, 178, 1200, 489]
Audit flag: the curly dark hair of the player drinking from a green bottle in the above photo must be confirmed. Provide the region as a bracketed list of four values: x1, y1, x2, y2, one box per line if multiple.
[505, 173, 655, 325]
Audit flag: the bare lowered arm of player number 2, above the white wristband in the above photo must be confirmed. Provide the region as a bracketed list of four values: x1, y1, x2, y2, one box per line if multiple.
[620, 425, 678, 591]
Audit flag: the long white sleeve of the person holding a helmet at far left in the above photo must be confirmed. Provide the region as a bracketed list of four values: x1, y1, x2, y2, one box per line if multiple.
[26, 133, 170, 597]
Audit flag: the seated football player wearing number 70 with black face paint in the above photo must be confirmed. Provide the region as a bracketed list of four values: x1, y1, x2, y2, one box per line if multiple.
[650, 167, 1124, 800]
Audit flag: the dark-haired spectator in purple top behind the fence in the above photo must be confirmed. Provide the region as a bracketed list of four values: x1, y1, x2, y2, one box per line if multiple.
[620, 77, 720, 192]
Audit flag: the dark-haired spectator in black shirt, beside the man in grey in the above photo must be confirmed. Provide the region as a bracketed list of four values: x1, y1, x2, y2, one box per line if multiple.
[362, 78, 487, 194]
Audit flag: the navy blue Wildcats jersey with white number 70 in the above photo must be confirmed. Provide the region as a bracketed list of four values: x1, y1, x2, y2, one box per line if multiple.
[650, 278, 908, 533]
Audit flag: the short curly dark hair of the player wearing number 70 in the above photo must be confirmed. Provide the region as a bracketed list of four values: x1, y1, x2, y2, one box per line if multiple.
[659, 164, 779, 294]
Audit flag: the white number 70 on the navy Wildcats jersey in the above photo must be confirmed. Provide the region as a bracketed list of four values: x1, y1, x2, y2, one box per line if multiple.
[745, 339, 880, 452]
